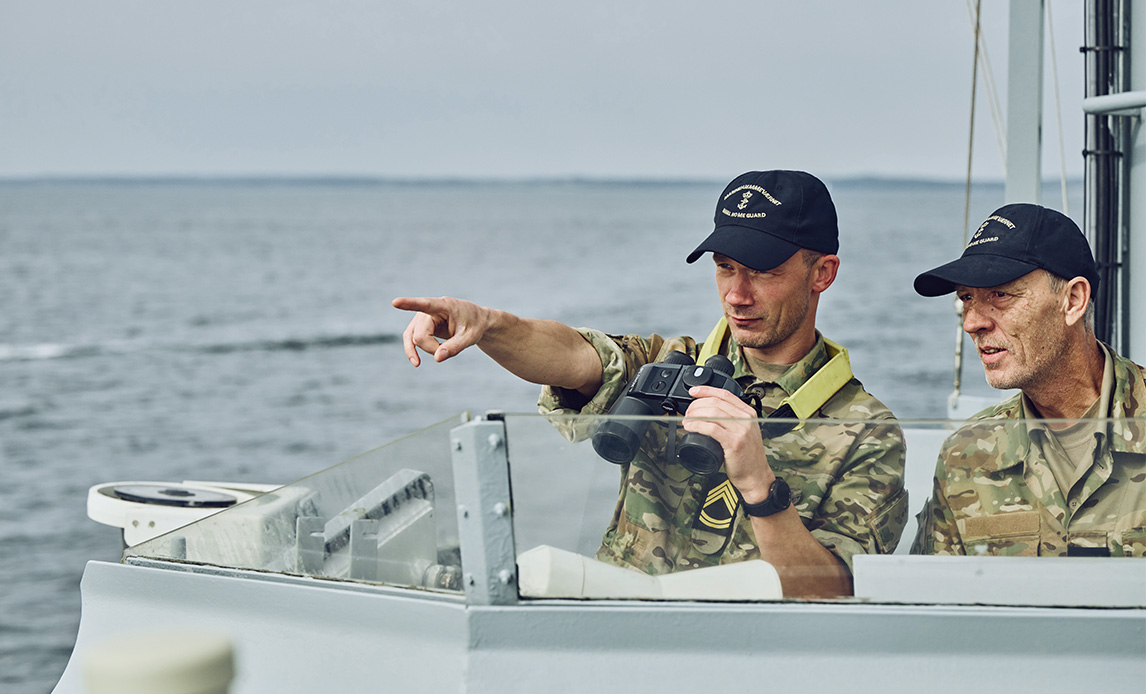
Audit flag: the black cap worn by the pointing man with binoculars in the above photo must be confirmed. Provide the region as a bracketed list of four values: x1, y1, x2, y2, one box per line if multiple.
[688, 171, 840, 273]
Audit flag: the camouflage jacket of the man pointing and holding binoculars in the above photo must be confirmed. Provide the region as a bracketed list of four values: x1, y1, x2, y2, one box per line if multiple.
[539, 330, 908, 574]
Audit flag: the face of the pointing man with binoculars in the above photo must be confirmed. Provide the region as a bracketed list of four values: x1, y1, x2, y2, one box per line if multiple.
[713, 252, 811, 350]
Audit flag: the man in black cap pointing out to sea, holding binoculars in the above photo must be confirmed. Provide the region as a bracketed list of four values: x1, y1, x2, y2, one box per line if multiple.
[394, 171, 906, 597]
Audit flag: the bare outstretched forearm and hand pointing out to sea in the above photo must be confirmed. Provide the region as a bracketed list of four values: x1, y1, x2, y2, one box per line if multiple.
[393, 297, 602, 396]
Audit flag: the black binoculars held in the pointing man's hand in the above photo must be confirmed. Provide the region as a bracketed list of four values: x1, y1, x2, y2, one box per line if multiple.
[592, 352, 744, 475]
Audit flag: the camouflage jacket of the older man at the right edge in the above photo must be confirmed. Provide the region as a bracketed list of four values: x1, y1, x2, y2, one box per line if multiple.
[911, 350, 1146, 557]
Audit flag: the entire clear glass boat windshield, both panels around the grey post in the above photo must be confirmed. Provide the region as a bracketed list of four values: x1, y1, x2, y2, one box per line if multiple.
[125, 415, 1146, 606]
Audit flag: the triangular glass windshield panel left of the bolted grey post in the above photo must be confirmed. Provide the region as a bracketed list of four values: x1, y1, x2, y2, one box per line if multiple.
[125, 418, 472, 592]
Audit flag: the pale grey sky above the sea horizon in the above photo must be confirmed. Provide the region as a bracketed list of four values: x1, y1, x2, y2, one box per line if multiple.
[0, 0, 1083, 180]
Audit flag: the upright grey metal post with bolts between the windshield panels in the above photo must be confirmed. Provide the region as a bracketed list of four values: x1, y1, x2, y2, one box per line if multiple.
[449, 419, 517, 605]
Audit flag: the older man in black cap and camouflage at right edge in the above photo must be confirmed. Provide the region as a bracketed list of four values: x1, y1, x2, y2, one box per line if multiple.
[912, 204, 1146, 557]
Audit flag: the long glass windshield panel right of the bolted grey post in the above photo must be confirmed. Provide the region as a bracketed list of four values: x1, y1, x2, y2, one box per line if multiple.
[505, 415, 1146, 606]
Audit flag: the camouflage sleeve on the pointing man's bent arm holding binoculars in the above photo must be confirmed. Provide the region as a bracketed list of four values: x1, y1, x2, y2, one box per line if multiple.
[809, 419, 908, 571]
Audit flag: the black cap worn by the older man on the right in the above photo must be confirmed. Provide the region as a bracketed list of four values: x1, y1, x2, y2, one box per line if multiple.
[915, 203, 1098, 297]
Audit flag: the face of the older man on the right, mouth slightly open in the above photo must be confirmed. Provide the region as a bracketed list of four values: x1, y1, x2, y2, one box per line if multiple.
[955, 270, 1068, 389]
